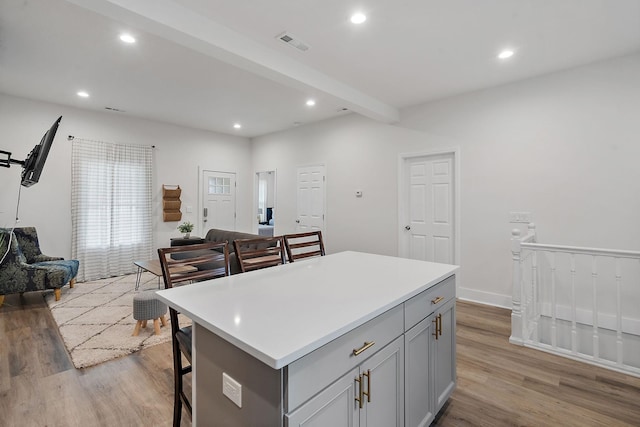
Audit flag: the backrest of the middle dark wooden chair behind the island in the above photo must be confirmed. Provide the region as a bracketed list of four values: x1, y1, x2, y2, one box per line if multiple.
[233, 236, 285, 273]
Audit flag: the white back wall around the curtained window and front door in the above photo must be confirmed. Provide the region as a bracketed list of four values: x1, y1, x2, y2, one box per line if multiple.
[0, 94, 253, 258]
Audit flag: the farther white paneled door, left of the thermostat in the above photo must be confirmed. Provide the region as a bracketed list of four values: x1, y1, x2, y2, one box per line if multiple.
[296, 165, 325, 233]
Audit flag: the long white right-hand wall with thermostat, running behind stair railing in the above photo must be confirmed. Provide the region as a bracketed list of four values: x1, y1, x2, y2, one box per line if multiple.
[252, 55, 640, 306]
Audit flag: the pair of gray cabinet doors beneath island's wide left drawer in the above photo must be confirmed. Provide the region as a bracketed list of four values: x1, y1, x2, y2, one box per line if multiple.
[285, 336, 404, 427]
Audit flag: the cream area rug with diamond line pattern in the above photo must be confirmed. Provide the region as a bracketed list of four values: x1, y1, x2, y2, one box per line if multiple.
[45, 272, 189, 368]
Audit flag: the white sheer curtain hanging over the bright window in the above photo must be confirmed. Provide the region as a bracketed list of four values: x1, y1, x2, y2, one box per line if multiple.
[71, 139, 153, 281]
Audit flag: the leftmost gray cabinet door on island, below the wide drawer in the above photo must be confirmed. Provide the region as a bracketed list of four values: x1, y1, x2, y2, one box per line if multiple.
[285, 368, 360, 427]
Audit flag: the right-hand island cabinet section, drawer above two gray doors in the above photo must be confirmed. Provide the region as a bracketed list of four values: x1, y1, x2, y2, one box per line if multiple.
[405, 277, 456, 427]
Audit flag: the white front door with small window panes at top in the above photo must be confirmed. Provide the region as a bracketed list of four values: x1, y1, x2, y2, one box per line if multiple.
[201, 170, 236, 232]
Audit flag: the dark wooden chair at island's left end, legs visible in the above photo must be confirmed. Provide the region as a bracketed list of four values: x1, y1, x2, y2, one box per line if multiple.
[158, 242, 229, 427]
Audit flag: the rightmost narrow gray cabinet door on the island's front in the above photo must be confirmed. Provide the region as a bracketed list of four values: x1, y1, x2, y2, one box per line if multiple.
[433, 298, 456, 413]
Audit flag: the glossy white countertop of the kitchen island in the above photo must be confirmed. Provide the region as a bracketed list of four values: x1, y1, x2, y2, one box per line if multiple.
[157, 252, 458, 369]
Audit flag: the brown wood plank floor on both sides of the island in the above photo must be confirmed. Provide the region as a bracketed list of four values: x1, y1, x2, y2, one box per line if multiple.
[0, 292, 640, 427]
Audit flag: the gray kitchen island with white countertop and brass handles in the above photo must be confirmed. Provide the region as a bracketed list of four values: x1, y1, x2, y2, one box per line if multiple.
[158, 252, 458, 426]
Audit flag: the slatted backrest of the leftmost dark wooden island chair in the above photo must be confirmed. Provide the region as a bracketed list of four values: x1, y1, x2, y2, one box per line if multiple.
[158, 242, 229, 289]
